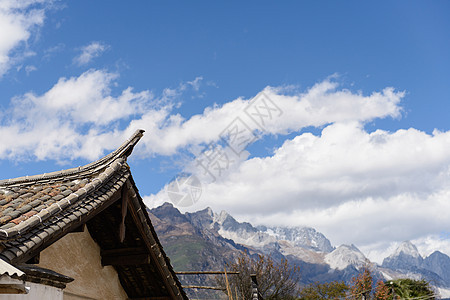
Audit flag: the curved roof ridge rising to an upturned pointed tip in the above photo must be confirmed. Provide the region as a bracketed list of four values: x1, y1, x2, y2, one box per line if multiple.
[0, 129, 145, 187]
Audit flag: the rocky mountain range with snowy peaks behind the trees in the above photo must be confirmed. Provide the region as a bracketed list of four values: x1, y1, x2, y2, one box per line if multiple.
[148, 203, 450, 298]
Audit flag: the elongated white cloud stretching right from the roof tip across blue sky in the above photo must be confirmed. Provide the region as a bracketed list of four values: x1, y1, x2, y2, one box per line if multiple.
[131, 80, 403, 155]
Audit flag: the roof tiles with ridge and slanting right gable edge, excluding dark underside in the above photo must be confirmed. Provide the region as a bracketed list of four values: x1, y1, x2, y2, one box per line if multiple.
[0, 131, 187, 299]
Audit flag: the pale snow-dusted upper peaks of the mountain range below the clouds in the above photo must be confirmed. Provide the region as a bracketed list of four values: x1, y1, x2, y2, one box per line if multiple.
[186, 208, 450, 286]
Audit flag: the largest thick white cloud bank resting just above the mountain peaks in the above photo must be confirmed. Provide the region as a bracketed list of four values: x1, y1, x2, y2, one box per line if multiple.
[146, 121, 450, 262]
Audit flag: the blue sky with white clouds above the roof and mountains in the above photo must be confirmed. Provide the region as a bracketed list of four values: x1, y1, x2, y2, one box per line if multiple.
[0, 0, 450, 259]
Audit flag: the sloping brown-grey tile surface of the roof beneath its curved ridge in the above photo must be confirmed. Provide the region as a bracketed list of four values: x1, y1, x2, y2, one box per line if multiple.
[0, 158, 130, 262]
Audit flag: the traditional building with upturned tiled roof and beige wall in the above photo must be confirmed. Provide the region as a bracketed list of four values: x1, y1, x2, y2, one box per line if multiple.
[0, 130, 187, 300]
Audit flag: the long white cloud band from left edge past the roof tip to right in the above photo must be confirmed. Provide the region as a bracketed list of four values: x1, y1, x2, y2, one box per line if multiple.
[0, 74, 403, 164]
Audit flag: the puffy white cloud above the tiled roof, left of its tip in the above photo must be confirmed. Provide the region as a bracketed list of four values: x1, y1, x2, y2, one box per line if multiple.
[0, 70, 151, 160]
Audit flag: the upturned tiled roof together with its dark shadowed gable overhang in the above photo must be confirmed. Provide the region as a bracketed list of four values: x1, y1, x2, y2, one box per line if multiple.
[0, 130, 187, 299]
